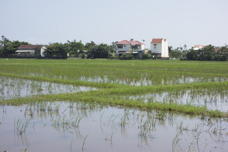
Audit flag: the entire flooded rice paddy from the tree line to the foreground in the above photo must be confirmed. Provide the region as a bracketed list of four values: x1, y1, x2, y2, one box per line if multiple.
[0, 59, 228, 152]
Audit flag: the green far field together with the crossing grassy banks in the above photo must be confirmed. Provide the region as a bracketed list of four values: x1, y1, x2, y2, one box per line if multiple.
[0, 59, 228, 119]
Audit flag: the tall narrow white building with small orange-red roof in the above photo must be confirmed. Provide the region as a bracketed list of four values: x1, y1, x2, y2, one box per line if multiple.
[150, 38, 169, 58]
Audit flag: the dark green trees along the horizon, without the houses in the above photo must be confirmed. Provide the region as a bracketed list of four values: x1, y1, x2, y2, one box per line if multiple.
[0, 36, 228, 61]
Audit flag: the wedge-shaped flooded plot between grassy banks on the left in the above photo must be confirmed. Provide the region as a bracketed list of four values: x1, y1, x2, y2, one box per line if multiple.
[0, 77, 95, 100]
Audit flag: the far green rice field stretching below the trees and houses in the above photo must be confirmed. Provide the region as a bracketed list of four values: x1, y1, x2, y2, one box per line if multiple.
[0, 59, 228, 85]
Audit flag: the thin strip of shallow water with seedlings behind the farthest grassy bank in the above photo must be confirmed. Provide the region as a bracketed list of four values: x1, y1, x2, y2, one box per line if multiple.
[29, 73, 228, 86]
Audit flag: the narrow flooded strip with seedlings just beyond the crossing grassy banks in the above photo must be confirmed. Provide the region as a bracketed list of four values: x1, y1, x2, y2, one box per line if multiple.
[29, 72, 228, 86]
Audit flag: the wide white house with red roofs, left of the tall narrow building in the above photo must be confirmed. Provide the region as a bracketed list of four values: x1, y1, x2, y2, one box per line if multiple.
[115, 39, 145, 55]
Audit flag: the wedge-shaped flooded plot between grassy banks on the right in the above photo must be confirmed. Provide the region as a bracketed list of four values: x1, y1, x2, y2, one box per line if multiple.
[125, 89, 228, 112]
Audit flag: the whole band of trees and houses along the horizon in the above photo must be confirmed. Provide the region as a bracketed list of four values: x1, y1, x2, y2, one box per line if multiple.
[0, 38, 228, 61]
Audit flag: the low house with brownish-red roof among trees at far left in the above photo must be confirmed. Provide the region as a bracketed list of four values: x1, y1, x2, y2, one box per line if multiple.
[16, 45, 47, 57]
